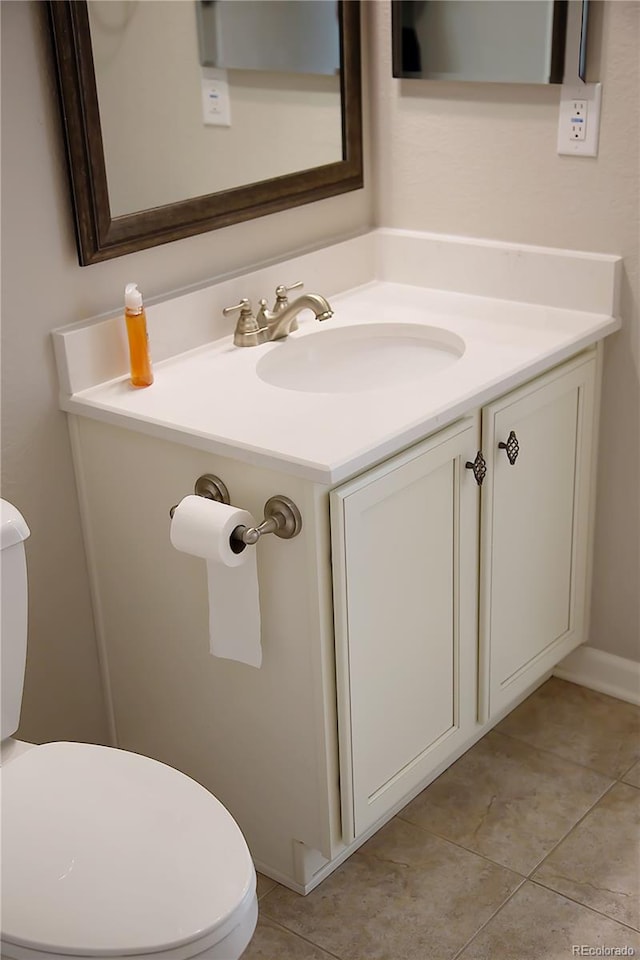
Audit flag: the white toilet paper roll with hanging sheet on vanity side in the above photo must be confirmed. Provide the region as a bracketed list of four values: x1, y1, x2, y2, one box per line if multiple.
[170, 496, 262, 667]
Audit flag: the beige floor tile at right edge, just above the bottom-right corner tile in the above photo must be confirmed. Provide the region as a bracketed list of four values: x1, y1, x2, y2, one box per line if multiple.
[534, 783, 640, 930]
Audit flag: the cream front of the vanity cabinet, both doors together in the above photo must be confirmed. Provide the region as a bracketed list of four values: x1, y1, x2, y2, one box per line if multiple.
[330, 352, 596, 841]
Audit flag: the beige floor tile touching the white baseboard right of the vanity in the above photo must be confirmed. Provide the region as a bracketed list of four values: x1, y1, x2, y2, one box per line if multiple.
[496, 677, 640, 778]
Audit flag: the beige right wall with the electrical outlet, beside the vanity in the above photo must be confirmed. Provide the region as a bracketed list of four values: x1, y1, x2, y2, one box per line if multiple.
[369, 0, 640, 660]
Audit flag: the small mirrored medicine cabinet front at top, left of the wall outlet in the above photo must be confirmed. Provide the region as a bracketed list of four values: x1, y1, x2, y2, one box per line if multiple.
[392, 0, 568, 83]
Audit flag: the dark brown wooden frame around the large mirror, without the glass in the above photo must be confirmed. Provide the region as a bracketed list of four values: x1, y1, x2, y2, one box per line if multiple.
[48, 0, 363, 266]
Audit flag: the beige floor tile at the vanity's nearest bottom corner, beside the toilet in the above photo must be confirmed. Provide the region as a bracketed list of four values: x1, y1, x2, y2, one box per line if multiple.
[260, 818, 520, 960]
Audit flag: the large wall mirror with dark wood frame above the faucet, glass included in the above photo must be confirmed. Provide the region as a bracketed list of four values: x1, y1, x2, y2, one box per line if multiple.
[49, 0, 363, 265]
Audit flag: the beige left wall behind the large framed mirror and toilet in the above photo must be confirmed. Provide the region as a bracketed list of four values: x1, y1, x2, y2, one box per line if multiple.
[0, 0, 372, 741]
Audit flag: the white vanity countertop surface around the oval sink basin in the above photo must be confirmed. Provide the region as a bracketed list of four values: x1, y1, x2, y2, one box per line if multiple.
[61, 278, 620, 484]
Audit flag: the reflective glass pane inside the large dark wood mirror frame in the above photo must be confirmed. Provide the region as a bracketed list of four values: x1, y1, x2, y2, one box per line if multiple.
[88, 0, 343, 217]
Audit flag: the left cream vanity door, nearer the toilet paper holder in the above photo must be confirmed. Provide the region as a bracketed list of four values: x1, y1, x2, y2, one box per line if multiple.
[330, 418, 479, 841]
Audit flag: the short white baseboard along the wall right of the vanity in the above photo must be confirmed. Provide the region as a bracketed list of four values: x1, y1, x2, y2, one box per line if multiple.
[553, 646, 640, 705]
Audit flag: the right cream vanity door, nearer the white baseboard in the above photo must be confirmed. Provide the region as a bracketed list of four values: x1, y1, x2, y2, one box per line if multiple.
[479, 355, 596, 720]
